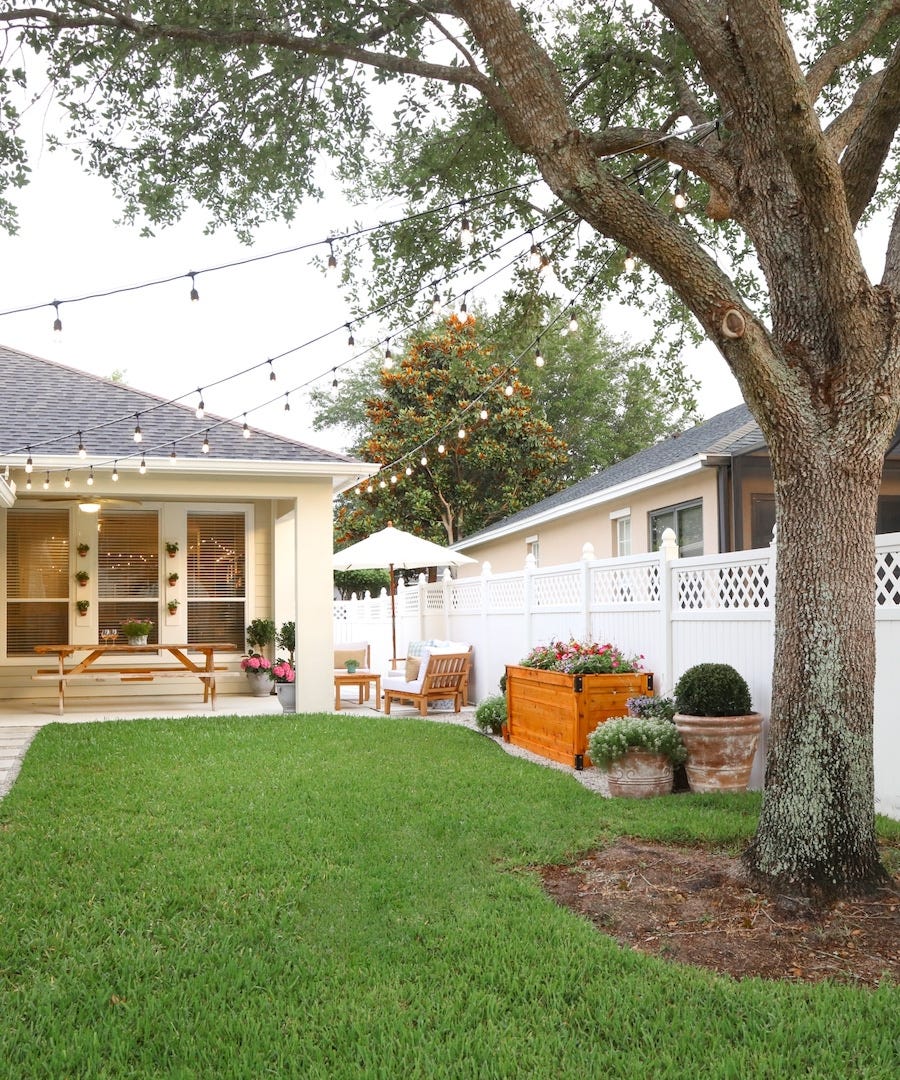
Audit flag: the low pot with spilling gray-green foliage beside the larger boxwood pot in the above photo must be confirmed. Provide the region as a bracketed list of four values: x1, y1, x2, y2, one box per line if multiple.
[588, 716, 687, 799]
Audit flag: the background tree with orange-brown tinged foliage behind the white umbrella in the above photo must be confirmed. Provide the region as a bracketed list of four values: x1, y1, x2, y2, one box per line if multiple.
[335, 315, 566, 546]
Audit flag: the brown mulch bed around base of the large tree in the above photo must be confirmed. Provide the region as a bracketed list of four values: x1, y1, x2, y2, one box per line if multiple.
[540, 840, 900, 987]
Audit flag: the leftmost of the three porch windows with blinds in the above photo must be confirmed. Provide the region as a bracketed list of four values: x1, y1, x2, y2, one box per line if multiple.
[6, 508, 70, 656]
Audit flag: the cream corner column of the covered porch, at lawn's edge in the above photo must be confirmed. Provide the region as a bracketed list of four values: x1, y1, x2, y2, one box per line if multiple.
[294, 486, 334, 713]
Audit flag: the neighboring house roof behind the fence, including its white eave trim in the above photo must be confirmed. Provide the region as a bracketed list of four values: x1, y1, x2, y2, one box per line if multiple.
[453, 405, 765, 549]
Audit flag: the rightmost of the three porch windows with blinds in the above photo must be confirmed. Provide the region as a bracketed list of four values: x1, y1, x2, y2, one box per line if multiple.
[187, 513, 246, 648]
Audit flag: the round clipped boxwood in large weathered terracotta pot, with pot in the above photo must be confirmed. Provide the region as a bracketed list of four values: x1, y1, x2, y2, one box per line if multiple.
[675, 663, 763, 792]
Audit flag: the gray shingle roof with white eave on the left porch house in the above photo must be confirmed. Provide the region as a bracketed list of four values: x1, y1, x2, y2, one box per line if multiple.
[0, 346, 373, 488]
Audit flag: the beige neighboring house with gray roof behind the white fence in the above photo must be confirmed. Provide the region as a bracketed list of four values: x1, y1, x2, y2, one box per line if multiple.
[454, 405, 900, 577]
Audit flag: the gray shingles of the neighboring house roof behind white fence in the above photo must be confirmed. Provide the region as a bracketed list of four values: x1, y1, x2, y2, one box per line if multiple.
[454, 404, 765, 546]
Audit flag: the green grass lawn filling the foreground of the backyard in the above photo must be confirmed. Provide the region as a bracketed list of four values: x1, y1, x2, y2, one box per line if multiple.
[0, 716, 900, 1080]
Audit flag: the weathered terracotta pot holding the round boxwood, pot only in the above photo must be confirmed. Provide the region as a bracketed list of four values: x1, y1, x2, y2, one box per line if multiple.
[675, 713, 763, 792]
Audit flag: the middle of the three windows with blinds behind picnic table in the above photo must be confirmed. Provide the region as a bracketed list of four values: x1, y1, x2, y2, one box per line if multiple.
[97, 510, 160, 643]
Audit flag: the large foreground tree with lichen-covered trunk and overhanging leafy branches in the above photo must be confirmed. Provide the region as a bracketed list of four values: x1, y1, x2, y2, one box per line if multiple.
[0, 0, 900, 890]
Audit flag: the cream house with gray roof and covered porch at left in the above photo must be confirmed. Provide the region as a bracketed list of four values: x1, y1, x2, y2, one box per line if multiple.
[0, 347, 376, 710]
